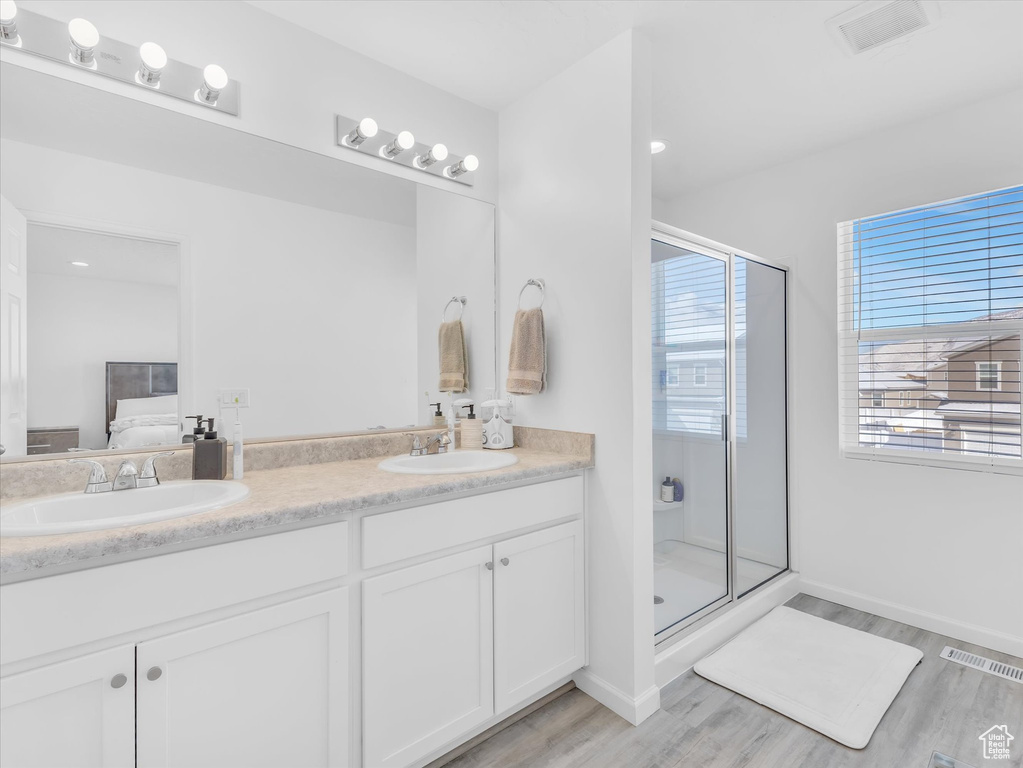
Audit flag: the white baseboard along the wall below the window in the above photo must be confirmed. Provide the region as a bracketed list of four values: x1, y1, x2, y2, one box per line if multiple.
[802, 579, 1023, 658]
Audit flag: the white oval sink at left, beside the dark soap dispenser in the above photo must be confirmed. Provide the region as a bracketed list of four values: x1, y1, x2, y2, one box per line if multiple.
[0, 480, 249, 536]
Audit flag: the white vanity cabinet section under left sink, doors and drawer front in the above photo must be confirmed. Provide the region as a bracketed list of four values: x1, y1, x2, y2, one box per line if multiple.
[0, 523, 352, 768]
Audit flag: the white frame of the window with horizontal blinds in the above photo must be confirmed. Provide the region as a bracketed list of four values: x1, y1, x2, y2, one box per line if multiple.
[836, 184, 1023, 476]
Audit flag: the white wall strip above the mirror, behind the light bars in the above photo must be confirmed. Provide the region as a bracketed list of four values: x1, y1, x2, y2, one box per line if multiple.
[0, 0, 497, 201]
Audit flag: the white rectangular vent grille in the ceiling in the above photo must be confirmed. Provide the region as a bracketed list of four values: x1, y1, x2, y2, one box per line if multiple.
[828, 0, 937, 55]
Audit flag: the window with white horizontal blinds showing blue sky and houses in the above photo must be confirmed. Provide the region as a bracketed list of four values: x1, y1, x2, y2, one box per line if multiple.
[838, 186, 1023, 471]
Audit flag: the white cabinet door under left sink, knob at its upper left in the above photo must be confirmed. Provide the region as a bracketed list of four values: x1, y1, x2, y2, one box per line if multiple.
[137, 587, 349, 768]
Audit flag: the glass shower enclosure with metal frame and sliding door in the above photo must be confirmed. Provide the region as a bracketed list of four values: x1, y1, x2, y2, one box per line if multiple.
[651, 226, 789, 642]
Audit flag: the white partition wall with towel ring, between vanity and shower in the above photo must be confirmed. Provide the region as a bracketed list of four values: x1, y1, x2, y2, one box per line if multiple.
[498, 32, 659, 721]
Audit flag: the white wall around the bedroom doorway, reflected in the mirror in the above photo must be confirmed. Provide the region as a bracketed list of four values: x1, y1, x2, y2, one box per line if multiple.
[0, 140, 420, 438]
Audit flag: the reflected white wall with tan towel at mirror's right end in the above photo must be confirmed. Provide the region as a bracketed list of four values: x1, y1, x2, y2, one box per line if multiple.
[415, 186, 496, 423]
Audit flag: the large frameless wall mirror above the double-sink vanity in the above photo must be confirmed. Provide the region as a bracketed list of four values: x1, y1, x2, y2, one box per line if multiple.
[0, 63, 496, 461]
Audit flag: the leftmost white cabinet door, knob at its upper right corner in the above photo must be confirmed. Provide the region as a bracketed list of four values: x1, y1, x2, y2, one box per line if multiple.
[0, 645, 135, 768]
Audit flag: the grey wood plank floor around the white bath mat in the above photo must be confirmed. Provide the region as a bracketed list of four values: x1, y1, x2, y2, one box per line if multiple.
[448, 595, 1023, 768]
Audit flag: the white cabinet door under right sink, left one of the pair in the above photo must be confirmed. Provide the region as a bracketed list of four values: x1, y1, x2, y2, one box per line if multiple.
[362, 547, 494, 768]
